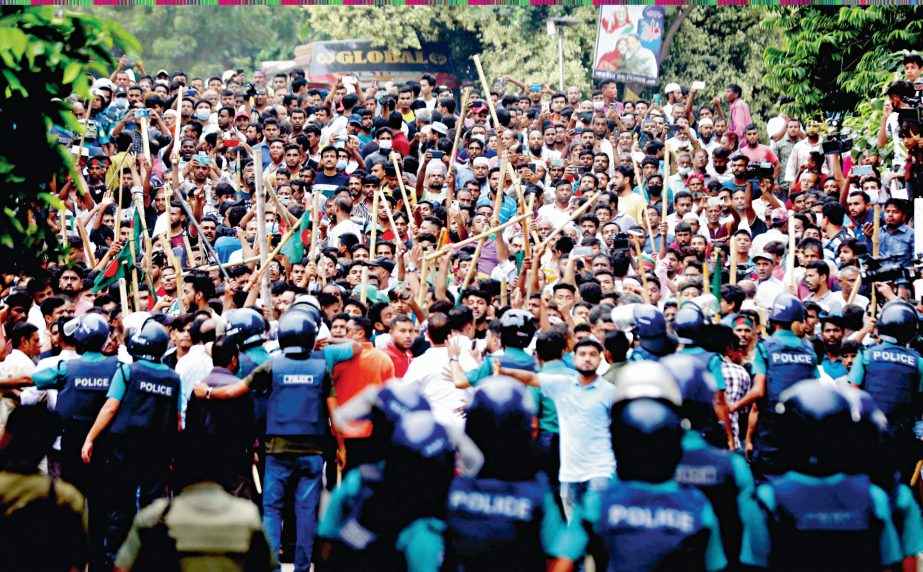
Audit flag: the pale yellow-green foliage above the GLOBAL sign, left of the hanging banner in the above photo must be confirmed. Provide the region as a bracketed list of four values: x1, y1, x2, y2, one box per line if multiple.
[306, 6, 599, 93]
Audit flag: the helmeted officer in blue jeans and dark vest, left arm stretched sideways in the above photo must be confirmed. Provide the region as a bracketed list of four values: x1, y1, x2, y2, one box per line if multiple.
[194, 311, 346, 571]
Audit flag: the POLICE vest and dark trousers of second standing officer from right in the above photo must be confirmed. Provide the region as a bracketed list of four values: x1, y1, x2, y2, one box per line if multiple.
[753, 330, 819, 475]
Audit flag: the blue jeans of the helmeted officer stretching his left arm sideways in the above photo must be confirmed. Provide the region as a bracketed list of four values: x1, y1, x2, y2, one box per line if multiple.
[263, 455, 324, 572]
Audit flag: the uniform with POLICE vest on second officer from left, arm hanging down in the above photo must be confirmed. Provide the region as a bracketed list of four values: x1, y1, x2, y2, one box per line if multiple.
[106, 359, 181, 556]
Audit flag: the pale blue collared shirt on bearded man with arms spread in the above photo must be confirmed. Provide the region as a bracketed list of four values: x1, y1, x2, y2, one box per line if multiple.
[538, 372, 615, 483]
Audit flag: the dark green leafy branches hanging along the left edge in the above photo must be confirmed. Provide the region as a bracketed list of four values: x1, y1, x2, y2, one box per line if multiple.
[0, 6, 138, 271]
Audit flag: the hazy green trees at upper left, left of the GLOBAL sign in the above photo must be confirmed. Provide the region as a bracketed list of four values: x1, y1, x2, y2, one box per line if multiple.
[83, 6, 304, 78]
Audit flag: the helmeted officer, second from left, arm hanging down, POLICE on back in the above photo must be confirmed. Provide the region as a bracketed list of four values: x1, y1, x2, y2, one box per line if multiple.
[82, 319, 182, 557]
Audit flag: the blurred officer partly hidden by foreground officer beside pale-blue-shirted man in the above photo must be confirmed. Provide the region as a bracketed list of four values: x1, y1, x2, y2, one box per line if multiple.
[660, 354, 766, 570]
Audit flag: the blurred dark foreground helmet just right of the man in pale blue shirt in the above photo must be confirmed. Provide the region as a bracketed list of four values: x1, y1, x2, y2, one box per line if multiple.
[612, 398, 682, 483]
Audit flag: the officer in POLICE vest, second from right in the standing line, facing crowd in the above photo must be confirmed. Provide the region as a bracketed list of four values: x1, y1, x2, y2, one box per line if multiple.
[730, 294, 820, 477]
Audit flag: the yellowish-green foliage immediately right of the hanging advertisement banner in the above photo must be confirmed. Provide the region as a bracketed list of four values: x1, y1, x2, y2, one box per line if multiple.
[660, 6, 779, 133]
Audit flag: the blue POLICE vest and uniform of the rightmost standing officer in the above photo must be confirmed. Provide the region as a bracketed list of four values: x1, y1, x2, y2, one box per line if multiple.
[848, 342, 923, 482]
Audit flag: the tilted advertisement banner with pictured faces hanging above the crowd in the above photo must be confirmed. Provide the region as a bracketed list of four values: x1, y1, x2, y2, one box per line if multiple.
[593, 6, 664, 85]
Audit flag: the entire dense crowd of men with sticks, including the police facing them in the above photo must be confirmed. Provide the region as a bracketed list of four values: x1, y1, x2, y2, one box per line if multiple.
[0, 48, 923, 571]
